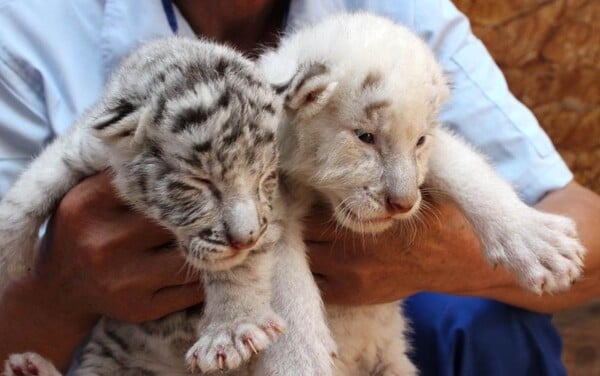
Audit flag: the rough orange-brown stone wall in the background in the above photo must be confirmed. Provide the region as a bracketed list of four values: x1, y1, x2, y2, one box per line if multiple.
[454, 0, 600, 193]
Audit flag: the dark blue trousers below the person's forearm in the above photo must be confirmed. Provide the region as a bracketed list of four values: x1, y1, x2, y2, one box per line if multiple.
[404, 293, 567, 376]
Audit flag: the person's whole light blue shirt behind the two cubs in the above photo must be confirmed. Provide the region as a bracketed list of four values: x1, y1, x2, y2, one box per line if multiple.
[0, 0, 572, 204]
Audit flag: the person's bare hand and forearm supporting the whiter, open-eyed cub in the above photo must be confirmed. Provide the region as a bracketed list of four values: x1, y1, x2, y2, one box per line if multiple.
[306, 182, 600, 313]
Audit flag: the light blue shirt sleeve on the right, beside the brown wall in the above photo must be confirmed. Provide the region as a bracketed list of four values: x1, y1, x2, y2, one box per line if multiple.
[414, 0, 573, 204]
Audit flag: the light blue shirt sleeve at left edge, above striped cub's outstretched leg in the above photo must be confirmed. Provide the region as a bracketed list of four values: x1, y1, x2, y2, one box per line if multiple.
[0, 49, 51, 197]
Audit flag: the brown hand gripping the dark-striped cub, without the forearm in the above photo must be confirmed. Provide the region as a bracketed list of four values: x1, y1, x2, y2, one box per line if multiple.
[32, 172, 202, 325]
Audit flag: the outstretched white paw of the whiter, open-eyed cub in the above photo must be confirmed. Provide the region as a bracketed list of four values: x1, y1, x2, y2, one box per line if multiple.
[482, 207, 586, 295]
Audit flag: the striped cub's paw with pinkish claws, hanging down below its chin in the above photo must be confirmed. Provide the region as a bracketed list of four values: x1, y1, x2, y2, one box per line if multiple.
[185, 312, 286, 373]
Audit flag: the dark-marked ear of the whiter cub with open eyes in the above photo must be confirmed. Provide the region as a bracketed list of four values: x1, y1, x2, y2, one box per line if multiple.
[279, 62, 338, 117]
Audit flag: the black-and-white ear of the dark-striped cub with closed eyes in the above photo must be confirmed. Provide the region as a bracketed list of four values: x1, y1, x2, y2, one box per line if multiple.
[91, 99, 151, 146]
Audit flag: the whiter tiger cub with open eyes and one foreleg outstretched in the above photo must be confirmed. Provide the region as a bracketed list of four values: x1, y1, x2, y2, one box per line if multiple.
[259, 13, 585, 376]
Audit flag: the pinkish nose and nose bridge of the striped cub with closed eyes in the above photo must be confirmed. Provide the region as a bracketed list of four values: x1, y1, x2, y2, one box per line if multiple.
[225, 200, 260, 250]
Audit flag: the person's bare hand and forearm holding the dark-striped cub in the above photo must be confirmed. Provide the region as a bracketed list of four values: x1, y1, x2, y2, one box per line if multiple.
[0, 173, 202, 369]
